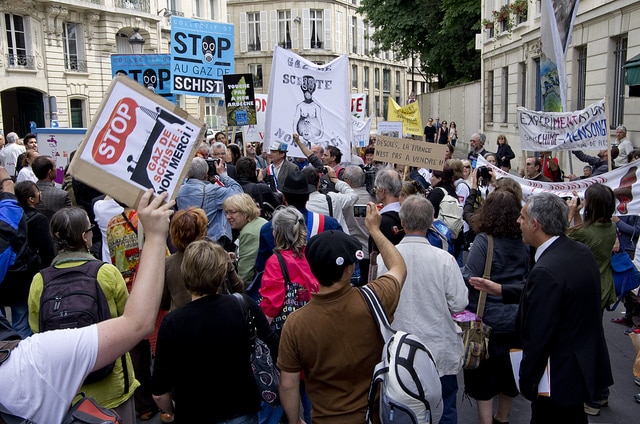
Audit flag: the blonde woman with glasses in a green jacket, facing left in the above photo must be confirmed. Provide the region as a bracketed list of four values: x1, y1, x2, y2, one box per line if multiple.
[222, 193, 267, 288]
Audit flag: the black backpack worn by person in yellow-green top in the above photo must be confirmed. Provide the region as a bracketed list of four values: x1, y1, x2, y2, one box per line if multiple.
[39, 260, 116, 384]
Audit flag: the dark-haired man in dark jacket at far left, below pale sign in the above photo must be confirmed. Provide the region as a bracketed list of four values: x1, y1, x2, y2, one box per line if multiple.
[31, 156, 72, 219]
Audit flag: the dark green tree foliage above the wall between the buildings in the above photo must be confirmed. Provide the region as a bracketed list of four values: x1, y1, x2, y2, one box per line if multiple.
[358, 0, 481, 88]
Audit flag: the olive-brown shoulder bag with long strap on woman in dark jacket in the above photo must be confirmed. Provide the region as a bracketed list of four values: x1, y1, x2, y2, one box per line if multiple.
[460, 235, 493, 370]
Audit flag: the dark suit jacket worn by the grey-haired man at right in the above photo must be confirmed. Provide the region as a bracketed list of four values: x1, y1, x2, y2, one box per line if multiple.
[518, 236, 613, 406]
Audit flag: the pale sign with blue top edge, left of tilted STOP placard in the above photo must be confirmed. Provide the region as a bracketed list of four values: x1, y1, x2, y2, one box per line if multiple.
[31, 126, 87, 184]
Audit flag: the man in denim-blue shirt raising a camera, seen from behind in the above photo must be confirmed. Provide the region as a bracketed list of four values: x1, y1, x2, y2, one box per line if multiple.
[176, 157, 243, 251]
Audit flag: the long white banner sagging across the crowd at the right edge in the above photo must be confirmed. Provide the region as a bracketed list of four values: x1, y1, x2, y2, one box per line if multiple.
[480, 156, 640, 215]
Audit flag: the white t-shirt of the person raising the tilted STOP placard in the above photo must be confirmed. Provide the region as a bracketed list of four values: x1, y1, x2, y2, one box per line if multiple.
[0, 324, 98, 423]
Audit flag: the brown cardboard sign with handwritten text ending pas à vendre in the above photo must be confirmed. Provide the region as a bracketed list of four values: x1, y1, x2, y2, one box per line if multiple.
[373, 135, 447, 171]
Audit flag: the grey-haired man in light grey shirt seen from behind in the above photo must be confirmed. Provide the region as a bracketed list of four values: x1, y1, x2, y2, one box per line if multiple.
[378, 195, 469, 423]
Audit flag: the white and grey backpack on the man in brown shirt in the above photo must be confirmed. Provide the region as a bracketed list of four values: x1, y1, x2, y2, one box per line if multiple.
[360, 286, 443, 424]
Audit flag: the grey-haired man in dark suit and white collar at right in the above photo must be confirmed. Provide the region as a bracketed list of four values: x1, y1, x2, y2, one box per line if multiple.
[518, 193, 613, 423]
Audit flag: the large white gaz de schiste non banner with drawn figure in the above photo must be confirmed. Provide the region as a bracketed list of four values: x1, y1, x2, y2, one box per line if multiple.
[265, 46, 352, 157]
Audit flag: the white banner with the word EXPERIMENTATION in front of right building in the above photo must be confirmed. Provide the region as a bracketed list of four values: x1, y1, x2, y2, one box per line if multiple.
[517, 99, 609, 151]
